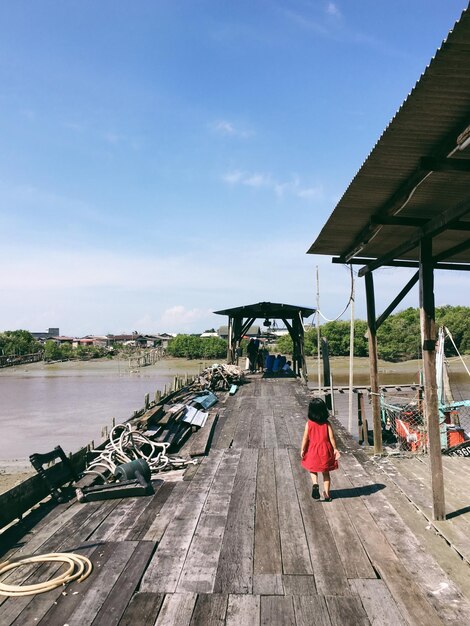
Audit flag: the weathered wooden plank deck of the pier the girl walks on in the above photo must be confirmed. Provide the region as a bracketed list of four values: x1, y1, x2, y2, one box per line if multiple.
[0, 376, 470, 626]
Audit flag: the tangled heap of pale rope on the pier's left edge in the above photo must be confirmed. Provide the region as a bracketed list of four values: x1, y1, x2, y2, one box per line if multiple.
[85, 423, 197, 481]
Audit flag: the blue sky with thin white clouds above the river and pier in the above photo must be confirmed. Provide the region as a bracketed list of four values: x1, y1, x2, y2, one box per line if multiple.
[0, 0, 470, 335]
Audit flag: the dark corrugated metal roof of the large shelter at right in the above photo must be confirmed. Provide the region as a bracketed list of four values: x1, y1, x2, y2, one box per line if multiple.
[308, 8, 470, 263]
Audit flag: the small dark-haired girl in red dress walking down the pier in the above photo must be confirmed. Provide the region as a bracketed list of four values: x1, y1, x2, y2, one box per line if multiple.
[300, 398, 340, 502]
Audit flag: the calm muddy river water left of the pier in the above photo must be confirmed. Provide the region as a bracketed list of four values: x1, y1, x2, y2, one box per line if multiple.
[0, 359, 206, 463]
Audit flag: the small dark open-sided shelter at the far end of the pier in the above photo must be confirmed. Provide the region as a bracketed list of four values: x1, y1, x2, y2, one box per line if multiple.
[214, 302, 315, 380]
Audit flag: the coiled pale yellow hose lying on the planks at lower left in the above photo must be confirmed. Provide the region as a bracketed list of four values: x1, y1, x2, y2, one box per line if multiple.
[0, 552, 93, 596]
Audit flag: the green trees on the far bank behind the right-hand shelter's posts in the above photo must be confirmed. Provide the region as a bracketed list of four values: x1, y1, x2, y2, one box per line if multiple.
[276, 305, 470, 362]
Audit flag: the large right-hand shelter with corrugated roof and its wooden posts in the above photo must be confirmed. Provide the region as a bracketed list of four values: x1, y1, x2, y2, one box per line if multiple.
[308, 8, 470, 519]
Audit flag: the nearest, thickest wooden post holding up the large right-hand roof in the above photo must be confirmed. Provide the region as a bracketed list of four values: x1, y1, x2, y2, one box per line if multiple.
[419, 238, 446, 520]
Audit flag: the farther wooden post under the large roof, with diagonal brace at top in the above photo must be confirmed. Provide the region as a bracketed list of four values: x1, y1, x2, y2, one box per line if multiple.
[365, 272, 382, 454]
